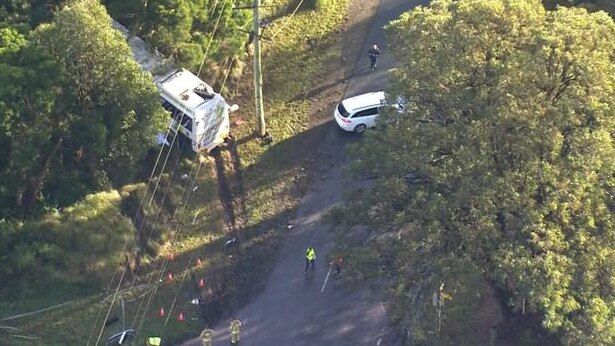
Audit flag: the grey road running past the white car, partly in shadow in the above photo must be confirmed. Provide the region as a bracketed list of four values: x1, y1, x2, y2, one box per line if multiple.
[184, 0, 427, 346]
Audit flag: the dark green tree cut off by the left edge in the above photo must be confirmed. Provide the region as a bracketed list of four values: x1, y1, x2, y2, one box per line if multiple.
[0, 27, 64, 215]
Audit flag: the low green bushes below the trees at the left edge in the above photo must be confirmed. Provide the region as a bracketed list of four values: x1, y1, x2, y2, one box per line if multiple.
[0, 190, 135, 294]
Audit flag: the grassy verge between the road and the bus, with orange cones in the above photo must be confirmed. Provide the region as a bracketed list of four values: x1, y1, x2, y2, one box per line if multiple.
[0, 0, 348, 345]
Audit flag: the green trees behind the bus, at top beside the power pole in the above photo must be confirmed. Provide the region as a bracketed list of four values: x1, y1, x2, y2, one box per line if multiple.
[104, 0, 252, 72]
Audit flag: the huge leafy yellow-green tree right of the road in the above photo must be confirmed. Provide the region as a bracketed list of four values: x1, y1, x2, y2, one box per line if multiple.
[355, 0, 615, 345]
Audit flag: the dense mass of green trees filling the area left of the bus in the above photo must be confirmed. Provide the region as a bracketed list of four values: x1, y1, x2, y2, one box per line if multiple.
[0, 1, 166, 216]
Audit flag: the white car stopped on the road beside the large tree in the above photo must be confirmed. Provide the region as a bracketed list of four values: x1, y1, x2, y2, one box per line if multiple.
[333, 91, 404, 133]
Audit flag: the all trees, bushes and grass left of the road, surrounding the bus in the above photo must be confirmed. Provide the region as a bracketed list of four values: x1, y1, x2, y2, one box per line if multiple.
[0, 0, 348, 345]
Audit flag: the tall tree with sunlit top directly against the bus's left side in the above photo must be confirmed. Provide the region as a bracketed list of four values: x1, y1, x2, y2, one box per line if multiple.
[35, 1, 166, 197]
